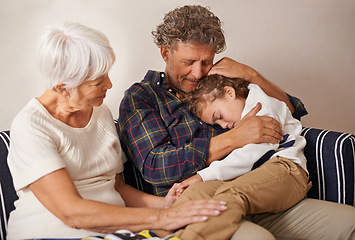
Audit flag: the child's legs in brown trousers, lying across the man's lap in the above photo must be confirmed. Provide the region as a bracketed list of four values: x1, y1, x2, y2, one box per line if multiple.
[177, 157, 310, 240]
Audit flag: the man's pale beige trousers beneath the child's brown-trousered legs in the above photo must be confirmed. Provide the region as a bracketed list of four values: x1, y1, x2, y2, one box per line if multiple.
[231, 198, 355, 240]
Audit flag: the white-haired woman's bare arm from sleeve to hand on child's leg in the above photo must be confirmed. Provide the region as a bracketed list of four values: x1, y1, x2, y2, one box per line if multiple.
[30, 169, 223, 233]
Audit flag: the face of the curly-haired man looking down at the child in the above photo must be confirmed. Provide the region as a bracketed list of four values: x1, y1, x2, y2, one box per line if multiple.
[161, 42, 215, 92]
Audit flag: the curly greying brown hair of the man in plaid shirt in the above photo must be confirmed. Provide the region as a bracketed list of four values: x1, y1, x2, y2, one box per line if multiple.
[152, 5, 226, 53]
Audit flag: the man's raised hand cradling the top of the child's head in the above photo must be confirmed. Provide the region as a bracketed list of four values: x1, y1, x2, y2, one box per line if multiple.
[208, 57, 258, 83]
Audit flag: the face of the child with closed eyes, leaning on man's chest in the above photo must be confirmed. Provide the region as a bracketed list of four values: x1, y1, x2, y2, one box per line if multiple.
[200, 87, 245, 129]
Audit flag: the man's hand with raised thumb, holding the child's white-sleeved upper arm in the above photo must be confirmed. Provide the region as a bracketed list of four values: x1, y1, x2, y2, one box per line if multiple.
[229, 103, 284, 146]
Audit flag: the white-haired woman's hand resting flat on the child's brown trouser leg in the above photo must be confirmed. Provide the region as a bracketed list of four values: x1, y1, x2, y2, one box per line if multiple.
[159, 199, 227, 230]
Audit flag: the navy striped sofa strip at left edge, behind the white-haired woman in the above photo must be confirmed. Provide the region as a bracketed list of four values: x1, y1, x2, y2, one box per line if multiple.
[0, 131, 17, 239]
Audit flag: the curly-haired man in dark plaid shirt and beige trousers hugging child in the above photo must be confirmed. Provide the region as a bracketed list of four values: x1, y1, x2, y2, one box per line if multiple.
[118, 6, 355, 240]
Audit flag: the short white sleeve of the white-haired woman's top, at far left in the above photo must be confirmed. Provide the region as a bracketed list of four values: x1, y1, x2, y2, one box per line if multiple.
[8, 109, 65, 190]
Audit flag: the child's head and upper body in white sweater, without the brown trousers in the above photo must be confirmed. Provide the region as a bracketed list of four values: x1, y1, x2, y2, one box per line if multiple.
[178, 75, 307, 187]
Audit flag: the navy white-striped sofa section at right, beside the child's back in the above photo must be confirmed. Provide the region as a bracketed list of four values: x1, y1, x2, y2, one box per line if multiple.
[302, 127, 355, 206]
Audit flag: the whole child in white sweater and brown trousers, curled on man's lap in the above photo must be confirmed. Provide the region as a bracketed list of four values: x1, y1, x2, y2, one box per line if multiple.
[170, 75, 311, 240]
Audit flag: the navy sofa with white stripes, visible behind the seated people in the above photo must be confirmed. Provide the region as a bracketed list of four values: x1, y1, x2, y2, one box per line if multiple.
[0, 127, 355, 239]
